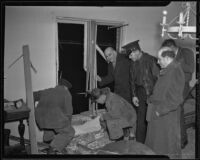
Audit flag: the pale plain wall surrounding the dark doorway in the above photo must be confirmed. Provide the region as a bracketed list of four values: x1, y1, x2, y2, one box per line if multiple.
[4, 2, 195, 141]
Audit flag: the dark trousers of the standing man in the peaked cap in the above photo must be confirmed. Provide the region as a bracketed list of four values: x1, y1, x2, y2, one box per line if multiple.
[136, 87, 147, 143]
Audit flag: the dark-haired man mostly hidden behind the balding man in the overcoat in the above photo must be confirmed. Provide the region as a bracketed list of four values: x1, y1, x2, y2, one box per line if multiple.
[162, 39, 194, 148]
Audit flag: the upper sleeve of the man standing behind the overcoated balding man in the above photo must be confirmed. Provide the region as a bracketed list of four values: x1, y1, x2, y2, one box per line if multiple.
[180, 48, 194, 73]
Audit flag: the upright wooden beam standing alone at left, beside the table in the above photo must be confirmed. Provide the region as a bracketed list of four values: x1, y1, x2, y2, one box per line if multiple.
[23, 45, 38, 154]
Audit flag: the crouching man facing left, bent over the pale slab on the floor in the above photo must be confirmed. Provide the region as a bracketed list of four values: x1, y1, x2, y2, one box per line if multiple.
[90, 87, 137, 141]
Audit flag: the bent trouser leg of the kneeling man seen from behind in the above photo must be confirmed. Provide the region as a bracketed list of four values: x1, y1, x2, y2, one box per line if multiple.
[50, 126, 75, 152]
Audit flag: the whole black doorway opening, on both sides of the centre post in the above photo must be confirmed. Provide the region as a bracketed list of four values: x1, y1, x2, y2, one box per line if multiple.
[57, 22, 122, 114]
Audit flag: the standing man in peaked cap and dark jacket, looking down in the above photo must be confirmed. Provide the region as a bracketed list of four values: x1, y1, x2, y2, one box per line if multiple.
[122, 40, 160, 143]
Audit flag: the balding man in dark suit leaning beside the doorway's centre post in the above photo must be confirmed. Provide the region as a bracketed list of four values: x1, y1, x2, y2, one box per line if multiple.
[97, 47, 131, 103]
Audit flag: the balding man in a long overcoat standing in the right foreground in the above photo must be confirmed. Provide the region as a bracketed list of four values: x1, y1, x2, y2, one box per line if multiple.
[145, 47, 185, 158]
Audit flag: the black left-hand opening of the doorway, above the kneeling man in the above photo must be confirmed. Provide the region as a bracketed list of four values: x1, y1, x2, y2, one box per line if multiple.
[58, 23, 88, 114]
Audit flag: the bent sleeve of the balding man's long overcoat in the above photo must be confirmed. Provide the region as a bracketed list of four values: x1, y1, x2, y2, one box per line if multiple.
[155, 68, 185, 116]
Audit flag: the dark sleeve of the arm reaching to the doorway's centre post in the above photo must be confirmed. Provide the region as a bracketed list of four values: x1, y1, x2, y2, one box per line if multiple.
[99, 64, 114, 86]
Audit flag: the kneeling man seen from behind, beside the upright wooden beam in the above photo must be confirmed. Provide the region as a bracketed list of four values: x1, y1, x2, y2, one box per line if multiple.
[34, 79, 75, 154]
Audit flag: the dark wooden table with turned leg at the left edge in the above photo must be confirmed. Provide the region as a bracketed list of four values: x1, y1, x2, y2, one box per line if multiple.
[4, 105, 30, 152]
